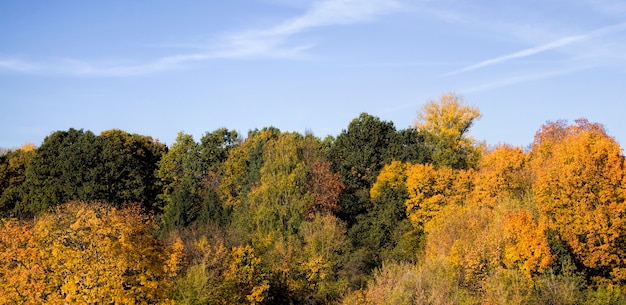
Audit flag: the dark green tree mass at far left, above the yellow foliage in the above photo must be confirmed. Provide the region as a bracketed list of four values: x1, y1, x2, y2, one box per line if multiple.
[15, 129, 166, 215]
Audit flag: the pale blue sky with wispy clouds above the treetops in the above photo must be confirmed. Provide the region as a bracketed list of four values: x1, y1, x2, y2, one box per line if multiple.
[0, 0, 626, 148]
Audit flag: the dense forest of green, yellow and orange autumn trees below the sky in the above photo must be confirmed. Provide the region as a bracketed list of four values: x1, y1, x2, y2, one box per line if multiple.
[0, 94, 626, 304]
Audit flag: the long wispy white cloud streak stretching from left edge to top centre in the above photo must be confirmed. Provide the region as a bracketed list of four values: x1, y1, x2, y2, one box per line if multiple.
[0, 0, 401, 77]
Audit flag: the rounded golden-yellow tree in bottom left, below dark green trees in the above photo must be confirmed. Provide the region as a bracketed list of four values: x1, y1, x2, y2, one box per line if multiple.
[35, 202, 182, 304]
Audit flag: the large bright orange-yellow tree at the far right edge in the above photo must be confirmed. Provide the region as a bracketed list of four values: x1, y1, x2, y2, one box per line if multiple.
[533, 120, 626, 283]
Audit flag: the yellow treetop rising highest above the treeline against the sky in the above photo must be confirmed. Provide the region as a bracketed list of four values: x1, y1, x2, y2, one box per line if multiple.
[415, 93, 480, 169]
